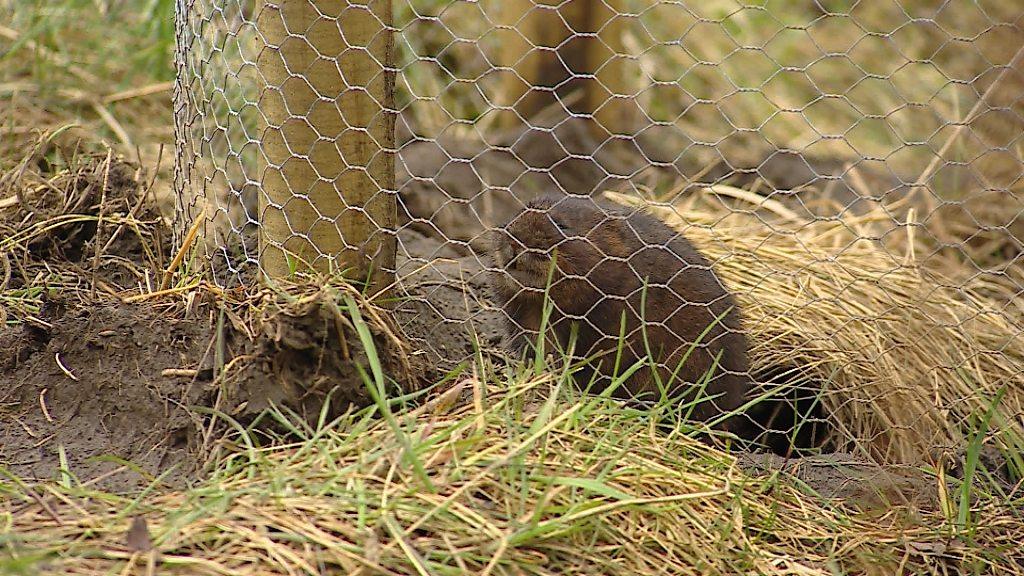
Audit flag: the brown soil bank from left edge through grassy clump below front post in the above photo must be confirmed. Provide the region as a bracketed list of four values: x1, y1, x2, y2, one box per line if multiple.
[0, 278, 452, 490]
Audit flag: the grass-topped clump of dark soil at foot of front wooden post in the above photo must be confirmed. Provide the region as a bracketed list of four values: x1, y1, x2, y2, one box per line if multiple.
[215, 283, 426, 422]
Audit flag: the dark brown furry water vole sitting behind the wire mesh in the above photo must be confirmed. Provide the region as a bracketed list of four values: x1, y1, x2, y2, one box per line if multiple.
[492, 195, 752, 420]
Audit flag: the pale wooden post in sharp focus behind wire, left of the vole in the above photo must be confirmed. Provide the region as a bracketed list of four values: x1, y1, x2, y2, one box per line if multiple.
[256, 0, 397, 290]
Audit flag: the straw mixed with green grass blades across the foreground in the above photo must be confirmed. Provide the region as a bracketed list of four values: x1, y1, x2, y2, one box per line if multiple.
[8, 376, 1024, 576]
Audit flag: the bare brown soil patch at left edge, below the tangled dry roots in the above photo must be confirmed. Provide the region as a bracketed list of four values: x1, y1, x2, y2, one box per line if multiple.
[0, 300, 210, 489]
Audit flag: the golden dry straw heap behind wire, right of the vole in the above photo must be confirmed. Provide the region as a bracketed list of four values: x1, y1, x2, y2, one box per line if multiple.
[606, 187, 1024, 463]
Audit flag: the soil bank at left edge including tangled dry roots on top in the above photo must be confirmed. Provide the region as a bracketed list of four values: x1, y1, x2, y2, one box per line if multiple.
[0, 150, 211, 488]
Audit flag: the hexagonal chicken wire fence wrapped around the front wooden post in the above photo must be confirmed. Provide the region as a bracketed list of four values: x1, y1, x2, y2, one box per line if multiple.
[174, 0, 1024, 459]
